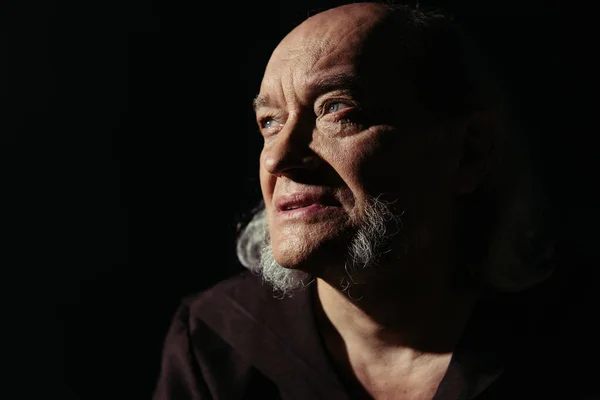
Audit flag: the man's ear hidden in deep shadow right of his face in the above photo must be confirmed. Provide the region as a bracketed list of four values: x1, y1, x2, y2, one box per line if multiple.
[453, 111, 497, 194]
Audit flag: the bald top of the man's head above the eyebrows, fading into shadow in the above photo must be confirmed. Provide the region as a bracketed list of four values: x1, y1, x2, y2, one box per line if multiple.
[259, 2, 491, 123]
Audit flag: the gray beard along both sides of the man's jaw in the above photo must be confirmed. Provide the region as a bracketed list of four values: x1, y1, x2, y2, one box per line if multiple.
[254, 198, 407, 297]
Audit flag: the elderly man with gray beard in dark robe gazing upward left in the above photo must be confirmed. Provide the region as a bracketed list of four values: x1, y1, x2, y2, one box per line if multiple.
[155, 3, 577, 400]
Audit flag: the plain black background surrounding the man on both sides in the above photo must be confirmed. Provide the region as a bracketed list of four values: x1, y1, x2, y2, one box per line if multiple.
[9, 0, 600, 399]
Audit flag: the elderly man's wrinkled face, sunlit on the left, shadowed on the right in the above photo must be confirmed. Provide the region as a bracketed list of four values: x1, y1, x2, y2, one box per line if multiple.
[255, 6, 460, 271]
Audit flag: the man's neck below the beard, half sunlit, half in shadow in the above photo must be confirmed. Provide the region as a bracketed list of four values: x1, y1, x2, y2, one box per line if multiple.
[317, 266, 478, 357]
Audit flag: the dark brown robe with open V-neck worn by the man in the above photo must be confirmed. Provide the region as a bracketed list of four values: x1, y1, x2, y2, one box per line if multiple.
[154, 272, 595, 400]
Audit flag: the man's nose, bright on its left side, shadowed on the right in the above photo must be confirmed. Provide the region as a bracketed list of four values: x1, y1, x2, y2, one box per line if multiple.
[262, 118, 320, 177]
